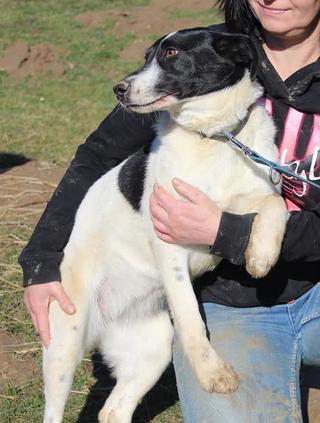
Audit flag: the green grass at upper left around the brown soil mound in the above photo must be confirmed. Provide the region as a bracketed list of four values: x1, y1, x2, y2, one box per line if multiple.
[0, 0, 149, 164]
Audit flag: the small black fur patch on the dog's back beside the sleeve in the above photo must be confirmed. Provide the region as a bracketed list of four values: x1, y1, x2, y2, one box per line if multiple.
[118, 147, 149, 211]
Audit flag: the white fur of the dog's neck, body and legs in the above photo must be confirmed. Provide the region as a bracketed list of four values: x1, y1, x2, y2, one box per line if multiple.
[44, 74, 287, 423]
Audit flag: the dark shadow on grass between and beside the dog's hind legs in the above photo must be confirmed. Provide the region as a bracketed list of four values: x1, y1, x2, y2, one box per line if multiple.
[77, 353, 178, 423]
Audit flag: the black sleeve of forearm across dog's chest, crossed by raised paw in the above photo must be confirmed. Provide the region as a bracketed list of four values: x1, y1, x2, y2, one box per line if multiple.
[210, 204, 320, 265]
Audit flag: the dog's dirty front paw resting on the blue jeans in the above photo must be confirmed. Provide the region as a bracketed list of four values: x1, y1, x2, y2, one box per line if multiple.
[195, 355, 239, 394]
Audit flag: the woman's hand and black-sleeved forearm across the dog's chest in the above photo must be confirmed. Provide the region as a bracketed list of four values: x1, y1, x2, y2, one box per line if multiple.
[150, 181, 320, 265]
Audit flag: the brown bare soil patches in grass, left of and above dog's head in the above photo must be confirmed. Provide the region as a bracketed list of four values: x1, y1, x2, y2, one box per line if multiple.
[0, 0, 213, 78]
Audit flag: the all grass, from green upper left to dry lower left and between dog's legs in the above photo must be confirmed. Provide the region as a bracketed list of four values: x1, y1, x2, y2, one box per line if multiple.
[0, 0, 222, 423]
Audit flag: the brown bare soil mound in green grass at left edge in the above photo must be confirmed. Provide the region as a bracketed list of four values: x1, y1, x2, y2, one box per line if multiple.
[0, 41, 64, 78]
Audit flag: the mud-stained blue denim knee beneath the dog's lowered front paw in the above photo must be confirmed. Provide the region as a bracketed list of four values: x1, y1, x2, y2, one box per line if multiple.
[174, 306, 302, 423]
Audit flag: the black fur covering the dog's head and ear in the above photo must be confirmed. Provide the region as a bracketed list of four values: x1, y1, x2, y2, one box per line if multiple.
[120, 28, 259, 106]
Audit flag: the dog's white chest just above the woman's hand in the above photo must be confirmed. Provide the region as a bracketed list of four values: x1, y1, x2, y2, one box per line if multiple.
[146, 128, 249, 208]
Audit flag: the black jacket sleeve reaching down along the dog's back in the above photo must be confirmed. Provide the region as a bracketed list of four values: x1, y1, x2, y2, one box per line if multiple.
[18, 106, 155, 286]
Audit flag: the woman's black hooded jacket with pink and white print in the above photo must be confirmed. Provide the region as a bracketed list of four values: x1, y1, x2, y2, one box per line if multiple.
[19, 29, 320, 306]
